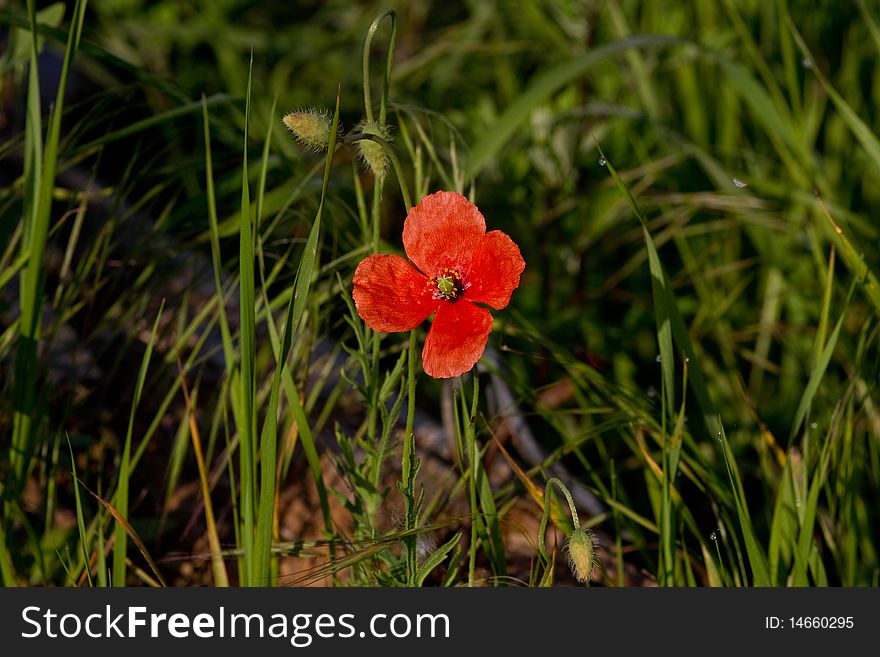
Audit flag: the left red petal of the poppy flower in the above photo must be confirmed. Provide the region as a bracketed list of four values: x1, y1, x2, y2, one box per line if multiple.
[352, 255, 440, 332]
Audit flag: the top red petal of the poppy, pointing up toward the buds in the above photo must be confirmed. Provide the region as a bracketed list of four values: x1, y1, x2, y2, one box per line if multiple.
[403, 192, 486, 276]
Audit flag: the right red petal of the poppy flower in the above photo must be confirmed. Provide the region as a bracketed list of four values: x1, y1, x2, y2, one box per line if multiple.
[464, 230, 526, 310]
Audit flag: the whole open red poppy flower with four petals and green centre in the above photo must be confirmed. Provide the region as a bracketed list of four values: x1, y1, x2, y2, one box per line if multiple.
[353, 192, 526, 379]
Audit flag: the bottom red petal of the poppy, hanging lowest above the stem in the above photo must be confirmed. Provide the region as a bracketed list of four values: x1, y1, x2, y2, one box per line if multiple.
[422, 299, 492, 379]
